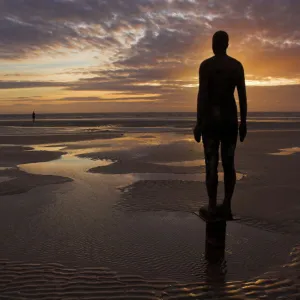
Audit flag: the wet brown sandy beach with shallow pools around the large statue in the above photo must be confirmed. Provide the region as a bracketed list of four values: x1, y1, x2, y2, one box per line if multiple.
[0, 114, 300, 300]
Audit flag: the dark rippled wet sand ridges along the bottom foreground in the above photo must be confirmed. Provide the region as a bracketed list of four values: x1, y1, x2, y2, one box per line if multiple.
[0, 250, 300, 300]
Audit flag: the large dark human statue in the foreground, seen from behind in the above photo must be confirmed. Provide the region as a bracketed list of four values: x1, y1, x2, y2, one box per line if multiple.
[194, 31, 247, 218]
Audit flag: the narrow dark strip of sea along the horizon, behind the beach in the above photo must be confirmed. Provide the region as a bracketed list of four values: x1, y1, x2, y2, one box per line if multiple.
[0, 112, 300, 132]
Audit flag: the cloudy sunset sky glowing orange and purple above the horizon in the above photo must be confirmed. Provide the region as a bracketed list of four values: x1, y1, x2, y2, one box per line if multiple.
[0, 0, 300, 113]
